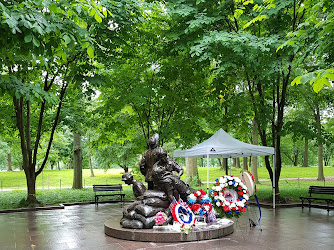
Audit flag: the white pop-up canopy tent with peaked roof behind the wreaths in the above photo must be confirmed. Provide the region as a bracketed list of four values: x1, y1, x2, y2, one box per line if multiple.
[173, 129, 275, 208]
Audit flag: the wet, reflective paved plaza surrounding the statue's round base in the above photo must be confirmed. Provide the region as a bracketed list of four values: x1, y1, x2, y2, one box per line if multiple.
[0, 203, 334, 250]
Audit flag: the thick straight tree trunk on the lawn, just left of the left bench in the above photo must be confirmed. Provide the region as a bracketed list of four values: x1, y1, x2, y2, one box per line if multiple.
[72, 132, 82, 189]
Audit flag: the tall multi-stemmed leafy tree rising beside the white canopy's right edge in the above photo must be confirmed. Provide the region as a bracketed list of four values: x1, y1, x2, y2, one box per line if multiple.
[167, 0, 318, 199]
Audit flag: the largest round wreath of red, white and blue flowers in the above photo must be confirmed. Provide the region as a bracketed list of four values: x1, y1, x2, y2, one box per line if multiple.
[210, 175, 249, 218]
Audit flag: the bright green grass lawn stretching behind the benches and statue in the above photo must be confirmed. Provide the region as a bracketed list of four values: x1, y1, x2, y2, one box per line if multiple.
[0, 167, 334, 210]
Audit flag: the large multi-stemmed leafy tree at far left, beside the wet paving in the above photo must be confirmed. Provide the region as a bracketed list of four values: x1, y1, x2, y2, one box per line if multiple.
[0, 0, 138, 205]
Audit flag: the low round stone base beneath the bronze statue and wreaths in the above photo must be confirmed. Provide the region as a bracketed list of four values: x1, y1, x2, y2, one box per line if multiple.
[104, 217, 234, 242]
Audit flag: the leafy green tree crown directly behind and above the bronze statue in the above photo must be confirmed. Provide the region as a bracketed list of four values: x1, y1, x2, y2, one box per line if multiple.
[99, 2, 207, 150]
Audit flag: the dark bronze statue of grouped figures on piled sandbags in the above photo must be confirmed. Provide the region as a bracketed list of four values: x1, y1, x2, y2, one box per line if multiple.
[120, 134, 191, 229]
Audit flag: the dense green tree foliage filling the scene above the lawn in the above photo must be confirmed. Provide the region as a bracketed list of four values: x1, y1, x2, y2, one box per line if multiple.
[0, 0, 334, 205]
